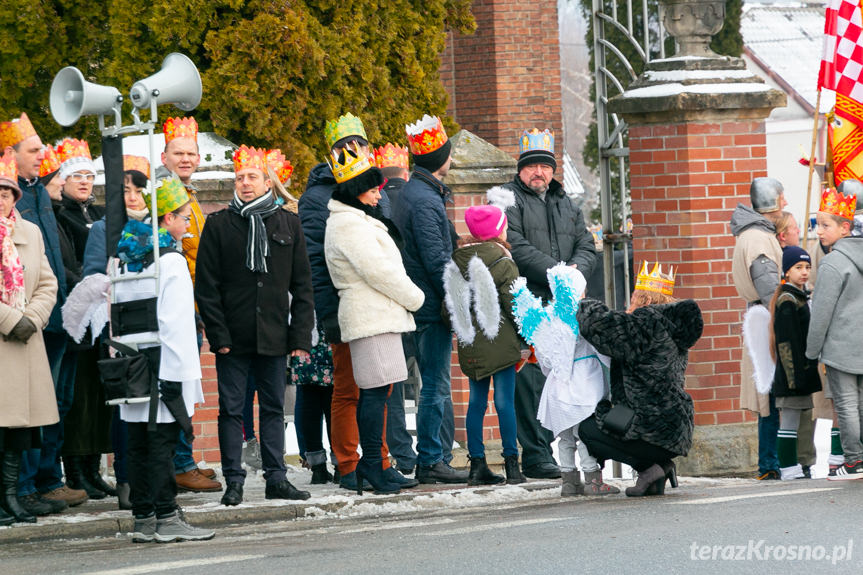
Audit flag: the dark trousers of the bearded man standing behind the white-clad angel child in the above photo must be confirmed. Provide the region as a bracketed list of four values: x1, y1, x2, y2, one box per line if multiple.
[515, 363, 555, 468]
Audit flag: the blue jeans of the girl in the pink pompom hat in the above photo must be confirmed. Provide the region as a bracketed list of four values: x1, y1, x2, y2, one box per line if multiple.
[465, 366, 518, 457]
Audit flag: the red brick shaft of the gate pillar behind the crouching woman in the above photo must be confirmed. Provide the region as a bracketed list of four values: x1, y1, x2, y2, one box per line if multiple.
[629, 120, 767, 425]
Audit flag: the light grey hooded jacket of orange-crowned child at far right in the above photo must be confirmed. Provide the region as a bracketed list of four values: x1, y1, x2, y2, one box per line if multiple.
[806, 237, 863, 374]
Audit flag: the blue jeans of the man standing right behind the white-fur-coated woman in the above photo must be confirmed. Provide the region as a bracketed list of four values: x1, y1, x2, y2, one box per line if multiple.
[415, 323, 452, 466]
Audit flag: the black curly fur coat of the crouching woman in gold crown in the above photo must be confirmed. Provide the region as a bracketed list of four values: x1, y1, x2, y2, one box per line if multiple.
[577, 299, 704, 455]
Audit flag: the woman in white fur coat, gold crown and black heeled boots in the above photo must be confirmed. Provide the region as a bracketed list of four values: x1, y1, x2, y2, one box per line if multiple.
[324, 148, 425, 493]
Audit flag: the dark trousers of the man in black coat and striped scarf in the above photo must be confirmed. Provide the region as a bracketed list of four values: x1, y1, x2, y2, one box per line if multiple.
[216, 353, 288, 483]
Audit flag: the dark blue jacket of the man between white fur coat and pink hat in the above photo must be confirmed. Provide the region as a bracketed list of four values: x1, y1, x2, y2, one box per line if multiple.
[393, 166, 453, 323]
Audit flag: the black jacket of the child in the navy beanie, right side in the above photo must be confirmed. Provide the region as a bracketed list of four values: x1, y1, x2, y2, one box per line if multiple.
[773, 283, 821, 397]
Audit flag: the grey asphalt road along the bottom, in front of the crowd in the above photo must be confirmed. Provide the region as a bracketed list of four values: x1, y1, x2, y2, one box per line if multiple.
[0, 480, 863, 575]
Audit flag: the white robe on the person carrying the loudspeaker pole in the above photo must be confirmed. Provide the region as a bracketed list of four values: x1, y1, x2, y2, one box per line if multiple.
[113, 253, 204, 423]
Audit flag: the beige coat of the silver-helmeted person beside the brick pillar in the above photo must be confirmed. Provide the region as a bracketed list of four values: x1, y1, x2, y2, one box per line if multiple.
[731, 223, 782, 417]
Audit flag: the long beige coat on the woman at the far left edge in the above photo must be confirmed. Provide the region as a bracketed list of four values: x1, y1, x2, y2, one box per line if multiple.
[0, 215, 60, 427]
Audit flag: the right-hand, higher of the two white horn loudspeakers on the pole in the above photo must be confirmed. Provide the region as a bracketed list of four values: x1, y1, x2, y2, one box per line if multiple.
[129, 52, 202, 112]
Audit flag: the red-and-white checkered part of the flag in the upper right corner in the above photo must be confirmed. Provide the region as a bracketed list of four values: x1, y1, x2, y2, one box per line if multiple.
[818, 0, 863, 102]
